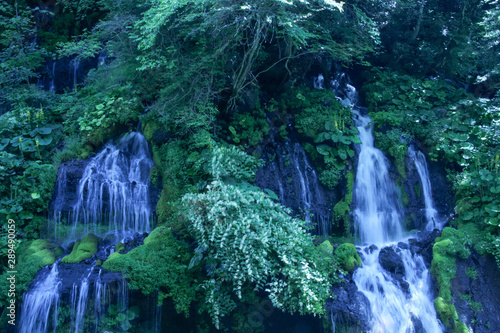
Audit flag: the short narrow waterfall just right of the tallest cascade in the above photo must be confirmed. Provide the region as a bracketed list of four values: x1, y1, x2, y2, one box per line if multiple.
[408, 146, 441, 231]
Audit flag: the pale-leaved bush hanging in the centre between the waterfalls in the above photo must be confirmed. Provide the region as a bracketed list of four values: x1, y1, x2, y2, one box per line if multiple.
[178, 146, 334, 327]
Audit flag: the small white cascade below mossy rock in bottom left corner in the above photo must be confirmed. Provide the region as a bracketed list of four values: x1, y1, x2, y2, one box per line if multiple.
[20, 263, 61, 333]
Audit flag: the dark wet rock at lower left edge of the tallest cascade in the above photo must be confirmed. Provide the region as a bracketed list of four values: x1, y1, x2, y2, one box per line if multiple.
[326, 280, 371, 332]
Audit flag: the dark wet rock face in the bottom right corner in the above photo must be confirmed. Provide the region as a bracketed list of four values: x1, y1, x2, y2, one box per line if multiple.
[451, 251, 500, 333]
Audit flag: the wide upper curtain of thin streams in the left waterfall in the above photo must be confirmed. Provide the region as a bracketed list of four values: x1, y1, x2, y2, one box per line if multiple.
[53, 132, 153, 240]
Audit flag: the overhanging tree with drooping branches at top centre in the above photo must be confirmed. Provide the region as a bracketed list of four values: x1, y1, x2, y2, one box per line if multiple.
[132, 0, 378, 131]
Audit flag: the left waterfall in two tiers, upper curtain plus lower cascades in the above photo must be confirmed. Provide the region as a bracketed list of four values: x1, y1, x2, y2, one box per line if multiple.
[21, 132, 156, 333]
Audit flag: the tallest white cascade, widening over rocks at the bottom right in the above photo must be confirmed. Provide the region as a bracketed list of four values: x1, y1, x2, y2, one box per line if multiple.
[332, 74, 442, 333]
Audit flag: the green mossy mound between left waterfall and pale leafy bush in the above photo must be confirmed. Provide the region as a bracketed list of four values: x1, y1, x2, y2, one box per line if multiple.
[102, 227, 196, 316]
